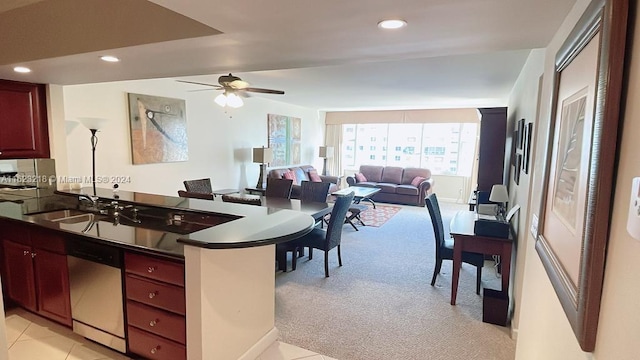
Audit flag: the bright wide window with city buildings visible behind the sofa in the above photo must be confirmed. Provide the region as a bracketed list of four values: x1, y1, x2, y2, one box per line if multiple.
[342, 123, 478, 176]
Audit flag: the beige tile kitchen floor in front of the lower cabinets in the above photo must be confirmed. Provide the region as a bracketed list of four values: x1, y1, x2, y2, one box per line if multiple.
[5, 309, 336, 360]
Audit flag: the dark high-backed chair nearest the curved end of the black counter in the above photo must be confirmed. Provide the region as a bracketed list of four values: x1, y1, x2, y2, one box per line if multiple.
[276, 192, 353, 277]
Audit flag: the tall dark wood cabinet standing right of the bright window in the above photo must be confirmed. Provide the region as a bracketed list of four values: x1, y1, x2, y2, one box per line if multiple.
[476, 107, 507, 191]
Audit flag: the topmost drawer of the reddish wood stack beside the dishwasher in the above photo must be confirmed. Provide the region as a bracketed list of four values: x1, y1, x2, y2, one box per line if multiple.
[124, 253, 184, 286]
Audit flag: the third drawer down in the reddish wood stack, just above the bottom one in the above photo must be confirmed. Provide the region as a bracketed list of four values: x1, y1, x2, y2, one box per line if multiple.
[127, 300, 187, 344]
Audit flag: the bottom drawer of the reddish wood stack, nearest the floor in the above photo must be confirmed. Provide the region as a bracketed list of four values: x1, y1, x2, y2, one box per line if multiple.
[128, 326, 187, 360]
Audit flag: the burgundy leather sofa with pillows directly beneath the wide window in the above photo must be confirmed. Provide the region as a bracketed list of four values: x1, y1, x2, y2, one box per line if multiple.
[347, 165, 433, 206]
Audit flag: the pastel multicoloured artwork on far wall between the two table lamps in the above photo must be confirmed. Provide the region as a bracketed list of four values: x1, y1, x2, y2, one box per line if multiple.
[267, 114, 302, 167]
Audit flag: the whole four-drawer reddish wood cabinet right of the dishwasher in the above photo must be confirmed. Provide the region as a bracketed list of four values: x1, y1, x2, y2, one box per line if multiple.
[124, 252, 187, 360]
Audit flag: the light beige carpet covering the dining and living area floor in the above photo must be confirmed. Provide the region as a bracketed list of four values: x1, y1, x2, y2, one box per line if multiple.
[276, 203, 515, 360]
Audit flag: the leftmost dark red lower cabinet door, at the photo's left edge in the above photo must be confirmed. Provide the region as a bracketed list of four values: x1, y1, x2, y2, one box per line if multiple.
[2, 240, 36, 311]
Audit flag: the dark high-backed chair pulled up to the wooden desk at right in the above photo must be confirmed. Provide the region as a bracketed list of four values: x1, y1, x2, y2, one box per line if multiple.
[425, 193, 484, 294]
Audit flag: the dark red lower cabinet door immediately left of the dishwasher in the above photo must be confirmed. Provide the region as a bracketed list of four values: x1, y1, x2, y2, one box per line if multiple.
[33, 248, 71, 325]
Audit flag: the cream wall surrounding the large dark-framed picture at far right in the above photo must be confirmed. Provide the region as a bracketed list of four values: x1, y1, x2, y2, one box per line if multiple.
[516, 0, 640, 360]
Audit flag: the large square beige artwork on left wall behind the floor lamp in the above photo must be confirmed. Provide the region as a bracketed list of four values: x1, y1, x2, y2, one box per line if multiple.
[128, 93, 189, 165]
